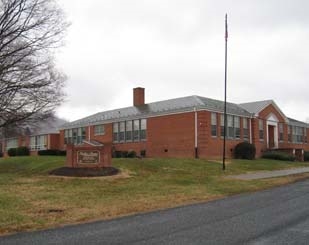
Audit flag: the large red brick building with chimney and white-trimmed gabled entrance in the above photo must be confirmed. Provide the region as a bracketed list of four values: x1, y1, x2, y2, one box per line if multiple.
[59, 88, 309, 158]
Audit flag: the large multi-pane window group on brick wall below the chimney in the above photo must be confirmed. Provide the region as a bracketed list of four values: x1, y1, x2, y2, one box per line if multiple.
[113, 119, 147, 142]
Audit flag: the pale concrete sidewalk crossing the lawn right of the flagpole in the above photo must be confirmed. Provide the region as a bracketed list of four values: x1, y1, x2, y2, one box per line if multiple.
[229, 167, 309, 180]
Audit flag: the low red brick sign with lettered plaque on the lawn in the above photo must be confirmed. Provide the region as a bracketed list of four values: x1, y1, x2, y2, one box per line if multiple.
[66, 144, 112, 168]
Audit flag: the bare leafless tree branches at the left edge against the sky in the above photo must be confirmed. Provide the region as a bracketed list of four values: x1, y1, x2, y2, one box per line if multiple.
[0, 0, 68, 129]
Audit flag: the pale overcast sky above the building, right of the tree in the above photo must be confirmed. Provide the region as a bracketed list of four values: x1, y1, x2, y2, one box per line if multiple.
[57, 0, 309, 121]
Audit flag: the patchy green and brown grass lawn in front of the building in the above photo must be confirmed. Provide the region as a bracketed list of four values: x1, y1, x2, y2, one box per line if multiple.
[0, 156, 309, 234]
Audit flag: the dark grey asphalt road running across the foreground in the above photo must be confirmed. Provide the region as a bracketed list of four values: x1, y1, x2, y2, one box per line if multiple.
[0, 180, 309, 245]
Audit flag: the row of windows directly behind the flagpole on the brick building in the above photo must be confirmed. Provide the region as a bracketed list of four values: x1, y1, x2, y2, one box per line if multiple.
[211, 112, 249, 140]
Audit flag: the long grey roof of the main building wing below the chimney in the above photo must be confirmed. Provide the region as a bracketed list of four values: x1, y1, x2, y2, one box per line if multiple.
[61, 95, 251, 129]
